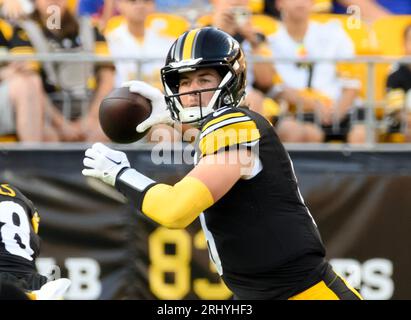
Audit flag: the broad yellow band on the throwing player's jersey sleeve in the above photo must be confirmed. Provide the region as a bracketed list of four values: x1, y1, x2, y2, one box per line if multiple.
[199, 120, 260, 155]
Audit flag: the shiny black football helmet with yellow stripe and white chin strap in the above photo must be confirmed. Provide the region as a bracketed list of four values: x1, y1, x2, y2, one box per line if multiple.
[161, 27, 246, 124]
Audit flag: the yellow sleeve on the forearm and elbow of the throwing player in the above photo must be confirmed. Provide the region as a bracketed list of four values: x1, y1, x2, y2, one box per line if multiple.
[142, 177, 214, 229]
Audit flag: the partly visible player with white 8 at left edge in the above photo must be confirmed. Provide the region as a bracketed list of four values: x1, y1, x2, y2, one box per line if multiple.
[0, 184, 70, 299]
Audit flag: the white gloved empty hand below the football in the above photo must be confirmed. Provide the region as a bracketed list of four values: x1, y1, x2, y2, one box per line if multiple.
[82, 143, 130, 187]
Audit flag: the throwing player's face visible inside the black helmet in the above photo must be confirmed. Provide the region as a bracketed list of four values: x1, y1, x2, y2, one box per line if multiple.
[178, 68, 221, 108]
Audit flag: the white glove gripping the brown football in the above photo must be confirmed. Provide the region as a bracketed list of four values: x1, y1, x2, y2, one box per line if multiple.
[122, 80, 174, 132]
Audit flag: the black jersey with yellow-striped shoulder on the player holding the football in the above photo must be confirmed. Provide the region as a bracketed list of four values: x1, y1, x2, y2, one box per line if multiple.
[196, 107, 326, 299]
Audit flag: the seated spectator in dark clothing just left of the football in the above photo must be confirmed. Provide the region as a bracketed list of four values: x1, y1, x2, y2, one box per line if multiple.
[14, 0, 114, 141]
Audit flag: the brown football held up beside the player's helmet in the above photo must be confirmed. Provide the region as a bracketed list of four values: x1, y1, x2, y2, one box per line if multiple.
[99, 88, 151, 143]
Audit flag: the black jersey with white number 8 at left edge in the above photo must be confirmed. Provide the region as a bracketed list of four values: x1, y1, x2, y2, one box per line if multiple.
[0, 184, 40, 274]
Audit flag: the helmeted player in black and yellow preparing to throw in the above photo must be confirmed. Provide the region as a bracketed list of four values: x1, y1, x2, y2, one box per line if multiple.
[83, 28, 361, 299]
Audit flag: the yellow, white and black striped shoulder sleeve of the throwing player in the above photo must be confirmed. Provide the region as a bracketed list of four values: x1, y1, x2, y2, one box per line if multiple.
[198, 108, 260, 157]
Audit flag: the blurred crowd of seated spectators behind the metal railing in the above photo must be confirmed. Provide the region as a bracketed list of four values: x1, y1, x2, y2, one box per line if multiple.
[0, 0, 411, 144]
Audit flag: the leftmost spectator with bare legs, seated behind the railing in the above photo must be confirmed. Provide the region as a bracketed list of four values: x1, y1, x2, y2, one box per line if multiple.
[0, 20, 58, 142]
